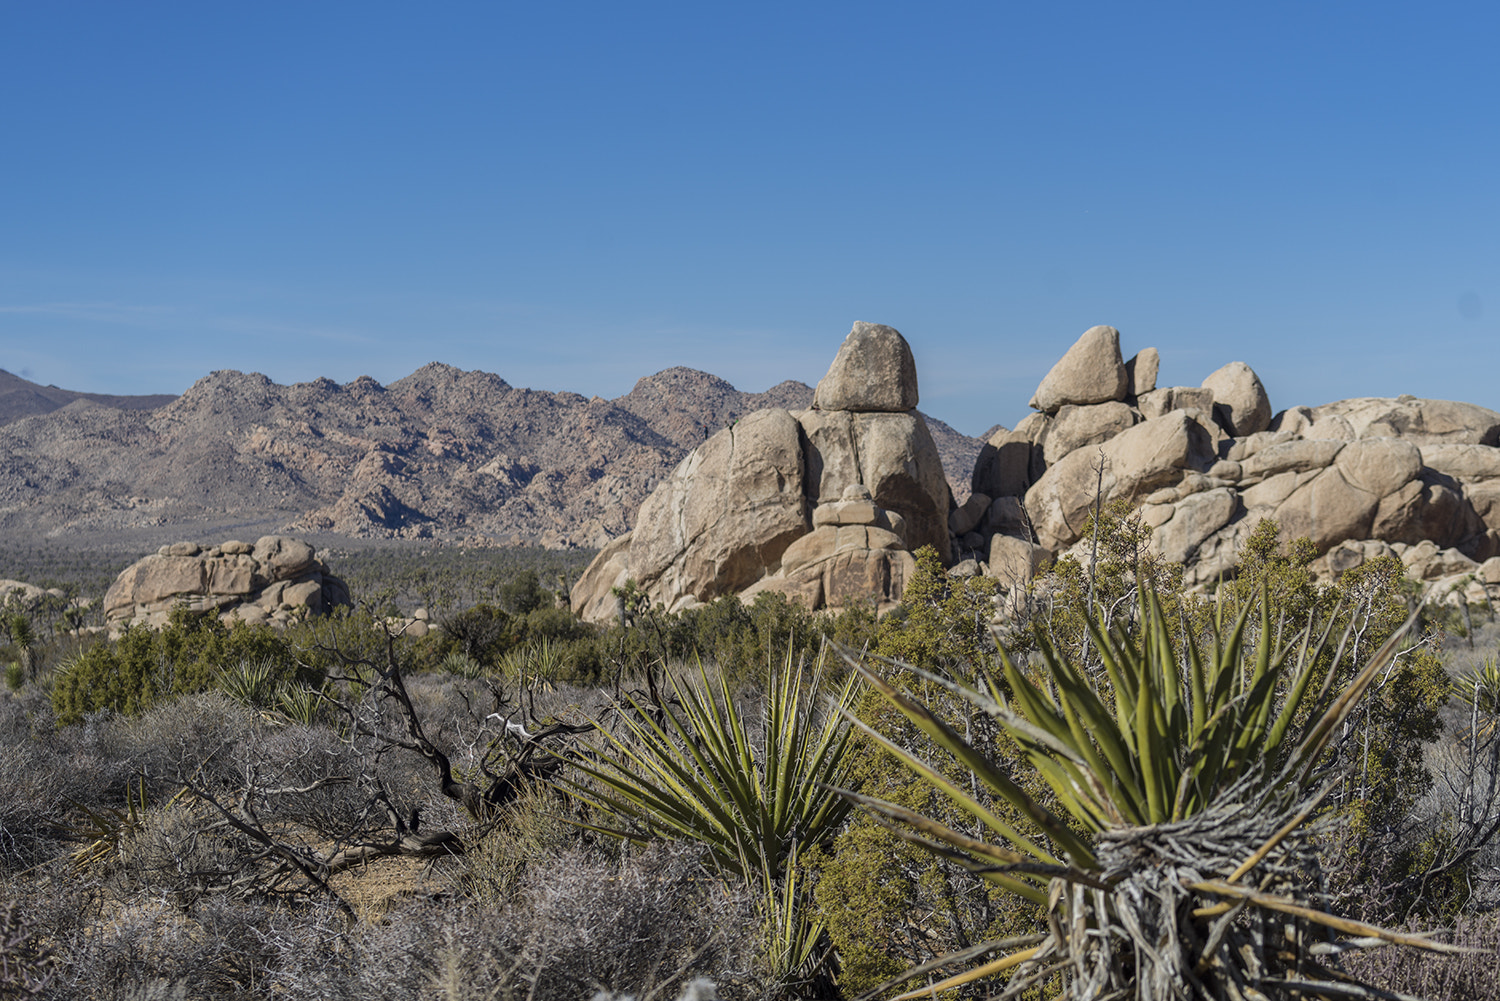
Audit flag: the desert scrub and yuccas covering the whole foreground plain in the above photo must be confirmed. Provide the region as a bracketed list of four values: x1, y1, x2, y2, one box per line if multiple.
[0, 522, 1500, 1001]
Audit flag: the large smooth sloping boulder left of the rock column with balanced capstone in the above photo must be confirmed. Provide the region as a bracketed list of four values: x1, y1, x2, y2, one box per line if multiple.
[630, 410, 812, 605]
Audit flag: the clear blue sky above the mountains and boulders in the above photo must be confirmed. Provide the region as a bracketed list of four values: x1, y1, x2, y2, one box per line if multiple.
[0, 0, 1500, 434]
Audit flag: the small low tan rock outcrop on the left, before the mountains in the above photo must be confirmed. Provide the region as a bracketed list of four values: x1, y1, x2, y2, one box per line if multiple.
[104, 536, 350, 630]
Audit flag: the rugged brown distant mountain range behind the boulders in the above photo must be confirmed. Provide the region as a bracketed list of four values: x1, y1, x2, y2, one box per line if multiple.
[0, 363, 983, 549]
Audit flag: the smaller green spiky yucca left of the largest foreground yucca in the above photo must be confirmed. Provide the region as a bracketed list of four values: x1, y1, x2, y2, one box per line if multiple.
[561, 653, 858, 977]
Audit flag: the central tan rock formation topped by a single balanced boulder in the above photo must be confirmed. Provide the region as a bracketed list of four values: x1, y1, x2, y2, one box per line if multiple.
[572, 323, 951, 621]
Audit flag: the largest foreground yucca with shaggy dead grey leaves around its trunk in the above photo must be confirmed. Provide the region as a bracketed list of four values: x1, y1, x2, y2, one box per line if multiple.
[846, 593, 1449, 1001]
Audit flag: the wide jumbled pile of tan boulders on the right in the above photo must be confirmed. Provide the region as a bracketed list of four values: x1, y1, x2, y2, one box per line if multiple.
[950, 327, 1500, 600]
